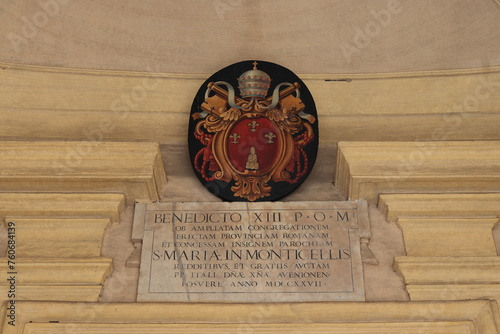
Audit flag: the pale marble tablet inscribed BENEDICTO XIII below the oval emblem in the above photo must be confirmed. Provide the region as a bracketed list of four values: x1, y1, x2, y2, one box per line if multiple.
[133, 202, 364, 302]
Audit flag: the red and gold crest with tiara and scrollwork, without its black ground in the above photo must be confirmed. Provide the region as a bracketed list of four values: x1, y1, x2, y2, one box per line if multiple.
[191, 62, 317, 201]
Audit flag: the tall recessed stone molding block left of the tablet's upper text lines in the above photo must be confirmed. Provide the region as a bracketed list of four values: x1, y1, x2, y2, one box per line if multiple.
[5, 217, 110, 262]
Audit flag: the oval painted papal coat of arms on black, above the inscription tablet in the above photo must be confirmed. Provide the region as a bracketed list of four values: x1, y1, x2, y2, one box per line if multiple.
[189, 61, 318, 201]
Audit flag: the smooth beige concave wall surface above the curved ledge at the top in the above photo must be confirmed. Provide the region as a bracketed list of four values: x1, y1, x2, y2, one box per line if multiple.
[0, 0, 500, 74]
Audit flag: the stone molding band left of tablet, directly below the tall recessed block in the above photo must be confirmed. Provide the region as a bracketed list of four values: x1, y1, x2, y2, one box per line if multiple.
[0, 258, 113, 286]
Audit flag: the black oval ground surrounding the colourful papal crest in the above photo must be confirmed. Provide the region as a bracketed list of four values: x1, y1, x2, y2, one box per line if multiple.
[188, 60, 319, 202]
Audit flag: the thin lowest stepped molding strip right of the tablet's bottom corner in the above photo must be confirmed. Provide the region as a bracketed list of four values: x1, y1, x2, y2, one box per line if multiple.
[406, 284, 500, 301]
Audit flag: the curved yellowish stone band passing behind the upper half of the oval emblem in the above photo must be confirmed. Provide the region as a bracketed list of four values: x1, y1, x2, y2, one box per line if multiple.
[0, 71, 500, 117]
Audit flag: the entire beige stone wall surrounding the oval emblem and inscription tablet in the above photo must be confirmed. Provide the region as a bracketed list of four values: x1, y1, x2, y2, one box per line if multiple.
[0, 0, 500, 334]
